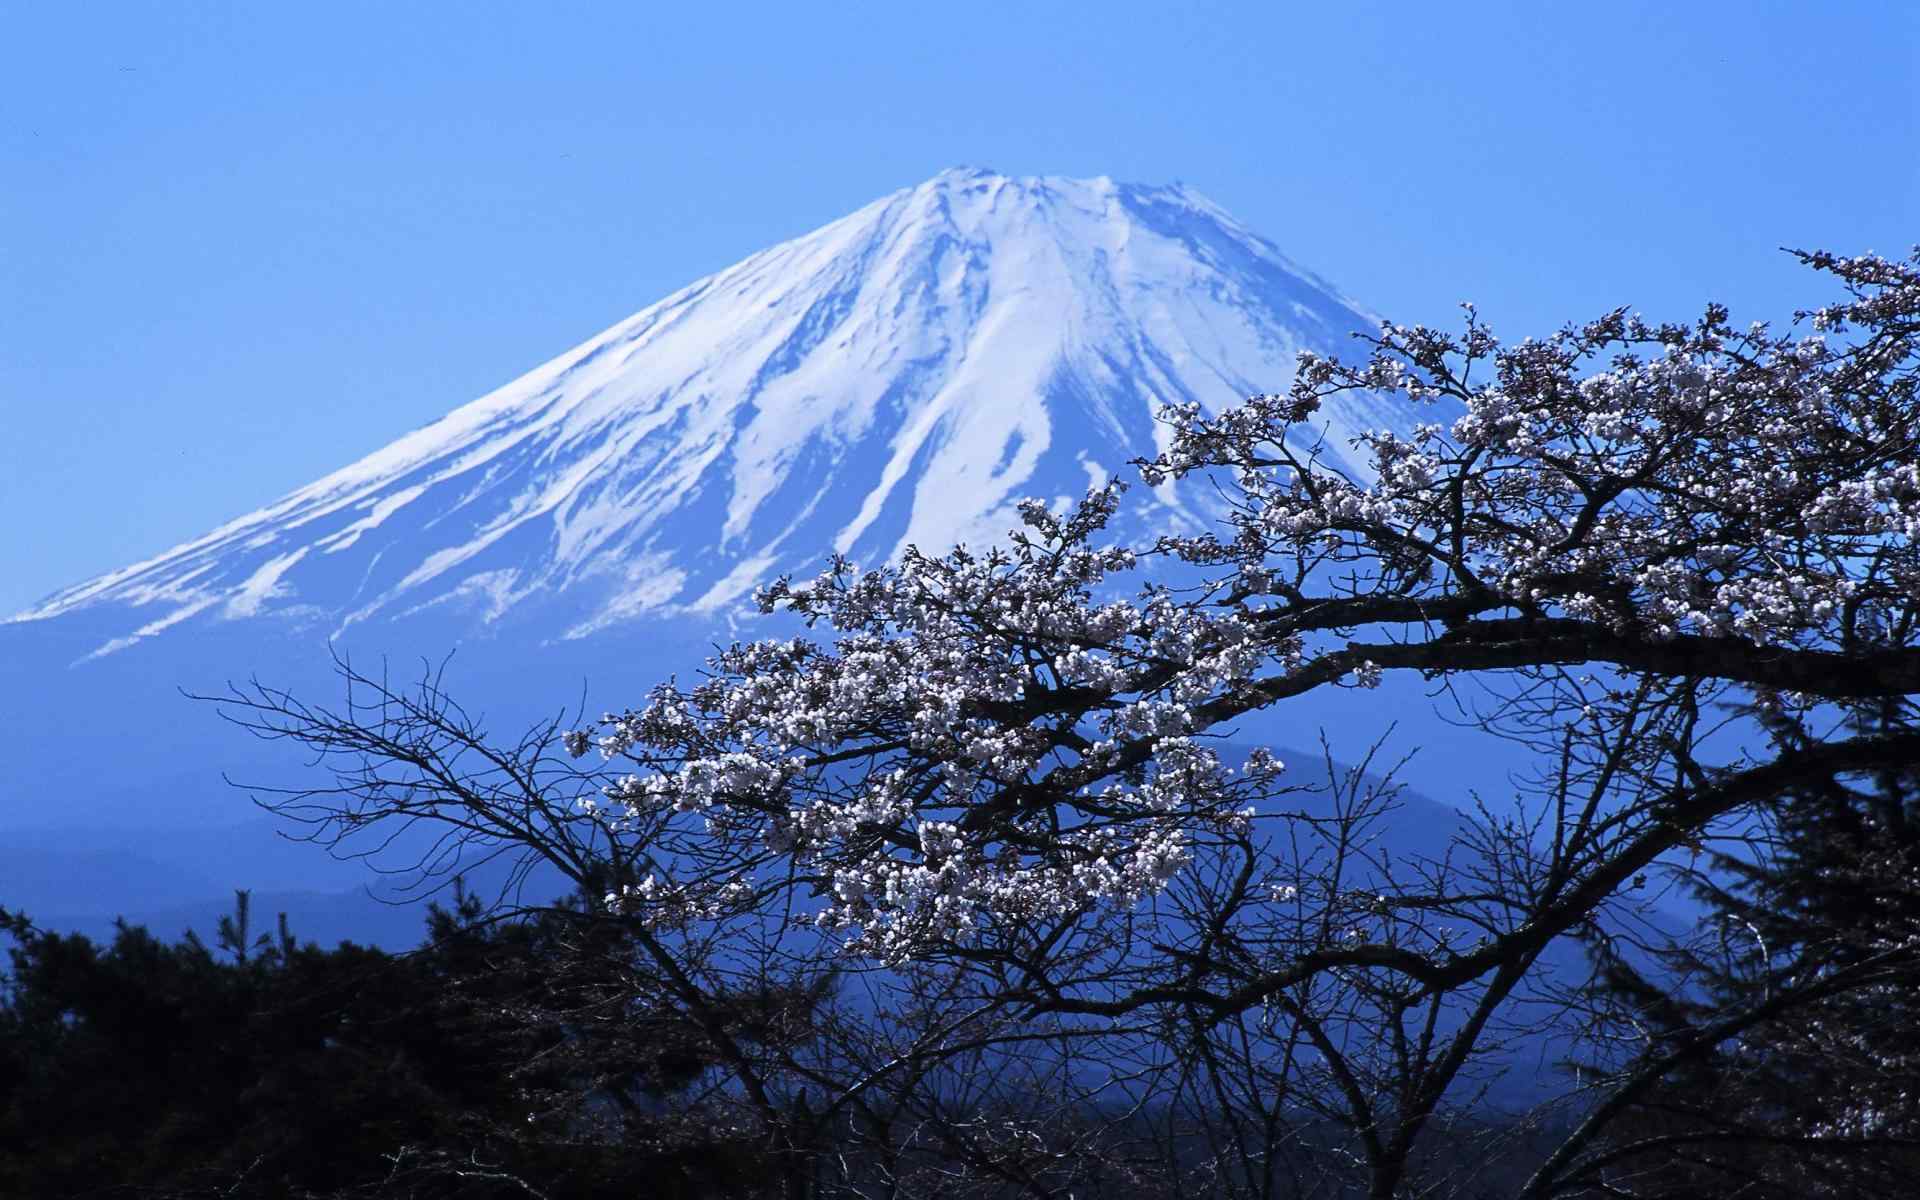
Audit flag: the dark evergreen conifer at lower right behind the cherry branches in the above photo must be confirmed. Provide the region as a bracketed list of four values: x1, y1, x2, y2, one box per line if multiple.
[1586, 708, 1920, 1200]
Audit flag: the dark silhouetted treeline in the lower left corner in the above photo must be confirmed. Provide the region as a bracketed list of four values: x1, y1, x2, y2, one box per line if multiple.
[0, 893, 780, 1200]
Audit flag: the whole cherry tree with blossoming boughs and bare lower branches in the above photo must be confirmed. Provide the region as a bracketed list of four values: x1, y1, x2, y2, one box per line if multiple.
[230, 253, 1920, 1196]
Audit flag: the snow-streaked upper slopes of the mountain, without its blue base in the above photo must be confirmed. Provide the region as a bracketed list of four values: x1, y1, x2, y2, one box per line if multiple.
[13, 171, 1409, 655]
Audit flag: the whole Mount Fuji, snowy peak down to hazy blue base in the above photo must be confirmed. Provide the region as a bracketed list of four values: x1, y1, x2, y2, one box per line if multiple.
[0, 171, 1459, 933]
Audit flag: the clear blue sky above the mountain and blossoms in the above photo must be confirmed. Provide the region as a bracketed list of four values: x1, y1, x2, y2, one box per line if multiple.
[0, 0, 1920, 612]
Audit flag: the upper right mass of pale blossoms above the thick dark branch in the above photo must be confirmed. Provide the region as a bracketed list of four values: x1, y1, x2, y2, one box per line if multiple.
[1146, 247, 1920, 647]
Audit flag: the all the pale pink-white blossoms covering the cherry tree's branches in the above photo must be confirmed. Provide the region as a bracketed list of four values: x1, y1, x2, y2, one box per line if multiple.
[568, 247, 1920, 958]
